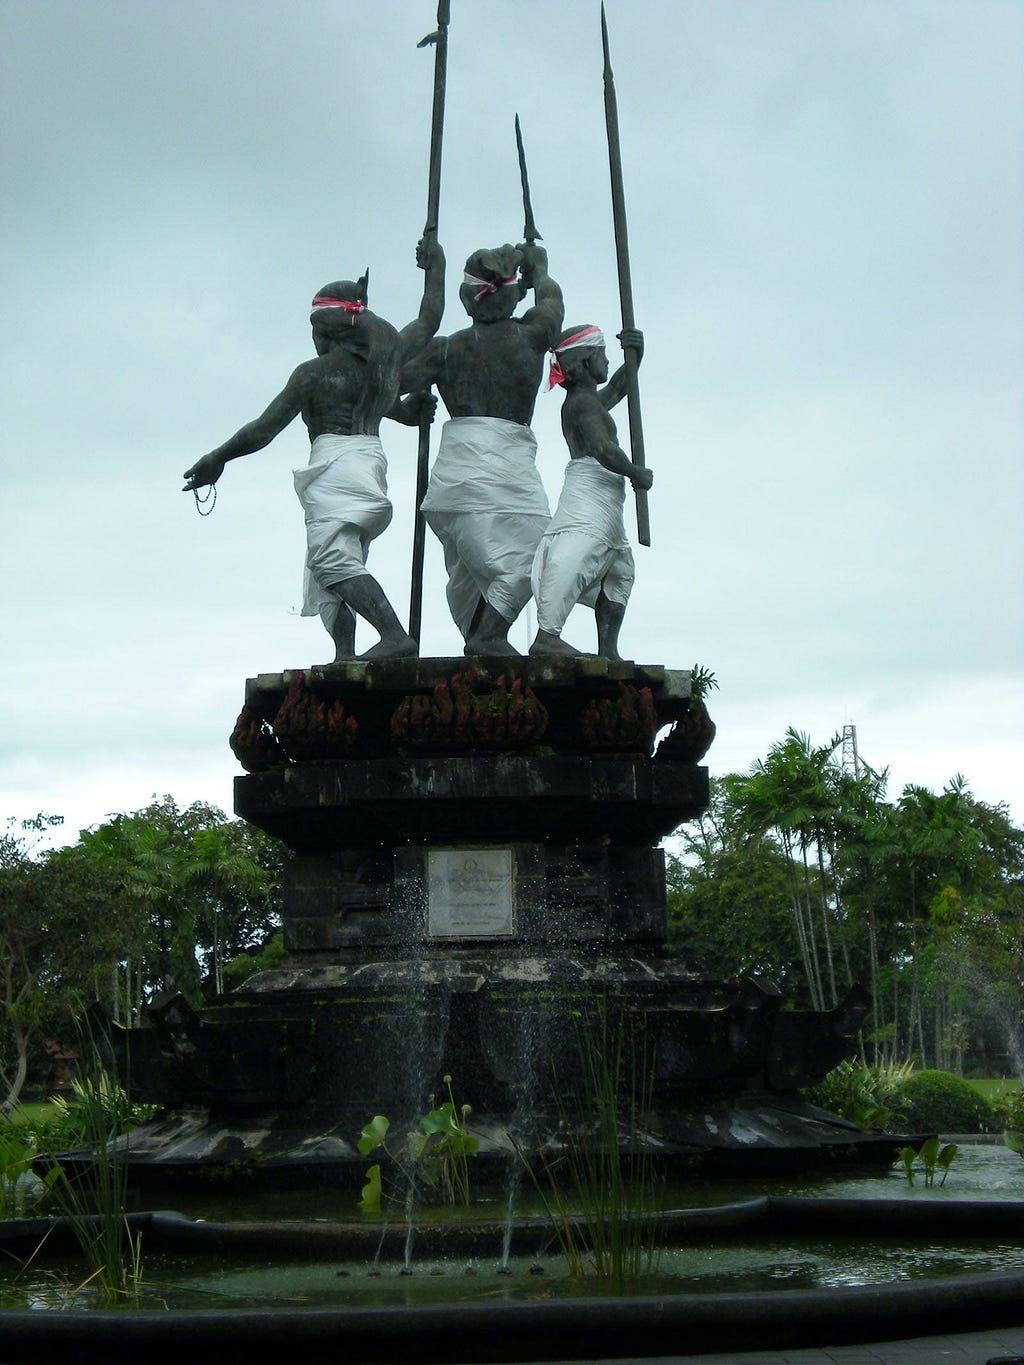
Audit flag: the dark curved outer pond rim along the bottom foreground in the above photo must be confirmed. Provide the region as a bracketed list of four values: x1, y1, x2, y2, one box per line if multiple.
[0, 1274, 1024, 1365]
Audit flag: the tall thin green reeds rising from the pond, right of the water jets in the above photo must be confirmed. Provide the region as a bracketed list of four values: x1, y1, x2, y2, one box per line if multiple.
[516, 998, 662, 1282]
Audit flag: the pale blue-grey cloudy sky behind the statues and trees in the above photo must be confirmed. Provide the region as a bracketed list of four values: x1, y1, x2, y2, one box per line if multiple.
[0, 0, 1024, 837]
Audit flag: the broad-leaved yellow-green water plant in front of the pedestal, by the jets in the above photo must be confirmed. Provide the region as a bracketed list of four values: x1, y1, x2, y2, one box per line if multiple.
[356, 1076, 479, 1213]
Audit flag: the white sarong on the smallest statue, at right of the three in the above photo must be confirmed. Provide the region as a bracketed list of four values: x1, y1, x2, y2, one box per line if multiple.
[532, 456, 636, 635]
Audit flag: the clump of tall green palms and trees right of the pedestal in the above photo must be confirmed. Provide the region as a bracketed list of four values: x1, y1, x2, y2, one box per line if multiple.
[682, 729, 1024, 1077]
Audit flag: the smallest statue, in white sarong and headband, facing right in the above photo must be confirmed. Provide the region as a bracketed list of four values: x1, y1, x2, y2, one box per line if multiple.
[530, 325, 654, 659]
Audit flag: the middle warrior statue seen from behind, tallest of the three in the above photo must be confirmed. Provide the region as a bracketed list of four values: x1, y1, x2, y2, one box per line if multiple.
[401, 242, 564, 655]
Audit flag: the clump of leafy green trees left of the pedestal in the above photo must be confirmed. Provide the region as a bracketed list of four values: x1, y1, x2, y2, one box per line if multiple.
[0, 797, 285, 1107]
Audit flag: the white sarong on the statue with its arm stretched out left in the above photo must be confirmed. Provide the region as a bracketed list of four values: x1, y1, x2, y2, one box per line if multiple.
[294, 435, 392, 631]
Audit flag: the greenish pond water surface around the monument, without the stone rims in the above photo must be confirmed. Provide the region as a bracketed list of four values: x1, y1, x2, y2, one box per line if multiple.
[0, 1144, 1024, 1309]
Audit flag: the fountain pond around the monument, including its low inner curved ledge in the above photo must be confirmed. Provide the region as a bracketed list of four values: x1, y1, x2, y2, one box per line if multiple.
[0, 1144, 1024, 1310]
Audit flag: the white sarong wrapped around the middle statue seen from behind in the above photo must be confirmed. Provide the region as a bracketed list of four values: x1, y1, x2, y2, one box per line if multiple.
[421, 418, 550, 639]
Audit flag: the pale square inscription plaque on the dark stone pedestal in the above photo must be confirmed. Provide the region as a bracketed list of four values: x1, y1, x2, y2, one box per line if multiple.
[427, 849, 513, 938]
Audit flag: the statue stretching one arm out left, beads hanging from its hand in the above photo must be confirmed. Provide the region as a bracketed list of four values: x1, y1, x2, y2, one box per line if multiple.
[184, 235, 445, 662]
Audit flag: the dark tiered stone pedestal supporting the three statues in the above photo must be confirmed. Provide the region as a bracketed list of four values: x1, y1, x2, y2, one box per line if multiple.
[102, 657, 890, 1181]
